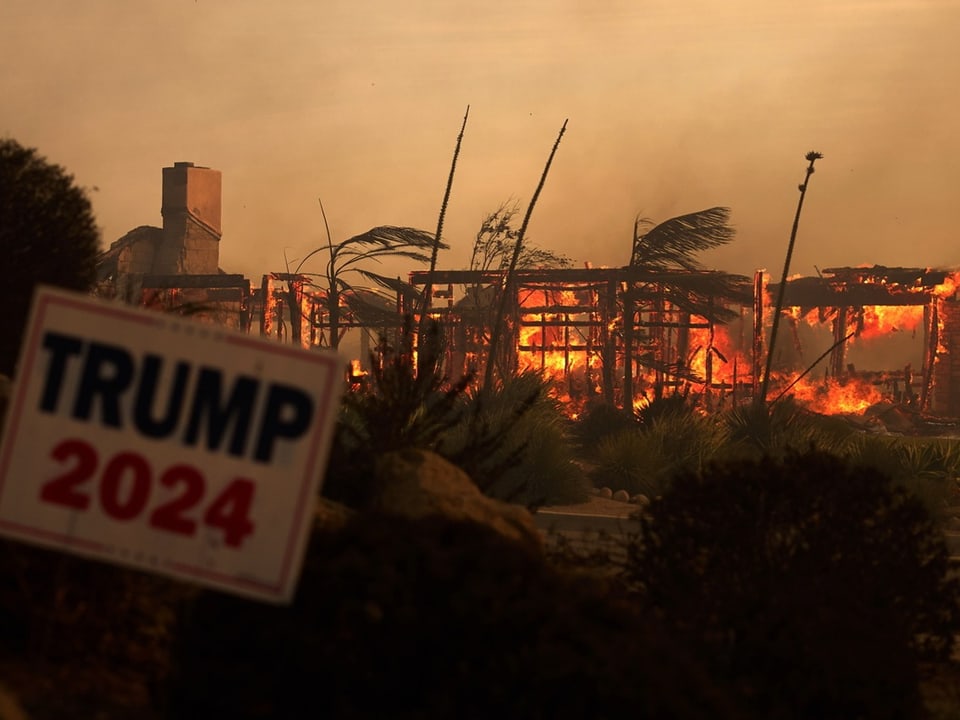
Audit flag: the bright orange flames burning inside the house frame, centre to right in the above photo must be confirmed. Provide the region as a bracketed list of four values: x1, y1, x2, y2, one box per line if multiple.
[488, 273, 960, 416]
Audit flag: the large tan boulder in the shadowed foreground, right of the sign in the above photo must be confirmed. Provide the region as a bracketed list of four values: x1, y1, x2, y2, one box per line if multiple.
[370, 449, 542, 548]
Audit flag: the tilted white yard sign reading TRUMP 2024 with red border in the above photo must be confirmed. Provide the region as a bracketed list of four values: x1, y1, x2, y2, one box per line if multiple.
[0, 288, 342, 602]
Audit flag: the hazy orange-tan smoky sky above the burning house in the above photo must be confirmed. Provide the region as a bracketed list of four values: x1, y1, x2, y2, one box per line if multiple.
[0, 0, 960, 279]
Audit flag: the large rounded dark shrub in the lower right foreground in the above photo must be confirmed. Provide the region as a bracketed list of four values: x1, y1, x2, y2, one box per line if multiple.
[627, 451, 960, 718]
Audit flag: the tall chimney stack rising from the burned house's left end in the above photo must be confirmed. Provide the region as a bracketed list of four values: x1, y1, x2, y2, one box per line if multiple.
[153, 162, 221, 275]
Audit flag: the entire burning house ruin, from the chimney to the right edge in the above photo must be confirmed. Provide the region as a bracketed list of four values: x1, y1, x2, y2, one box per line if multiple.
[99, 162, 960, 418]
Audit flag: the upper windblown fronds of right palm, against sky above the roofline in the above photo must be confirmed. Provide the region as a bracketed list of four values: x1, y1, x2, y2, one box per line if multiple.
[630, 207, 735, 270]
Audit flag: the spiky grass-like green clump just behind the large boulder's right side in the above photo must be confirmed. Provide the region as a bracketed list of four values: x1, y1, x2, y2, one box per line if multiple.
[437, 372, 589, 506]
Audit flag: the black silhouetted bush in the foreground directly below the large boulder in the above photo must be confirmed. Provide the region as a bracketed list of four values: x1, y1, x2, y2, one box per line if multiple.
[169, 514, 742, 720]
